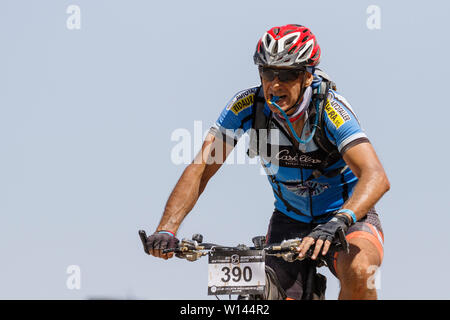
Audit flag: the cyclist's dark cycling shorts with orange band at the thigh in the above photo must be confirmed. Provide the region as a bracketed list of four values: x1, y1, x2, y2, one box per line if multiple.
[266, 209, 383, 300]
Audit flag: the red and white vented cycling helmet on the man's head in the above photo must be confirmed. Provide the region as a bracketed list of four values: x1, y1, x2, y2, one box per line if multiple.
[253, 24, 320, 68]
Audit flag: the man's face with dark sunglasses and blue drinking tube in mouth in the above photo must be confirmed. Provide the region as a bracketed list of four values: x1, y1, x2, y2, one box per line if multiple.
[260, 68, 312, 113]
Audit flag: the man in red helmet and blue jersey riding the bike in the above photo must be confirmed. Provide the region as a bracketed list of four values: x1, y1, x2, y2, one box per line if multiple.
[147, 24, 390, 299]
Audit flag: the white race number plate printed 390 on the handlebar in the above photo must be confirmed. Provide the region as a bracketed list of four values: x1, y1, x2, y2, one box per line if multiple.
[208, 250, 265, 295]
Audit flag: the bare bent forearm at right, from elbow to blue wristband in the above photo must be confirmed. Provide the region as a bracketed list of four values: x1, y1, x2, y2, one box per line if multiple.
[342, 171, 390, 220]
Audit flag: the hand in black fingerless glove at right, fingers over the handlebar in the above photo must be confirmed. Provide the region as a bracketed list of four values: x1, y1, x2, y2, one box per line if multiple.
[298, 214, 352, 260]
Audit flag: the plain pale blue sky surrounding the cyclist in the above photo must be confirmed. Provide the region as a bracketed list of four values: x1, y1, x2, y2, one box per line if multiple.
[0, 0, 450, 299]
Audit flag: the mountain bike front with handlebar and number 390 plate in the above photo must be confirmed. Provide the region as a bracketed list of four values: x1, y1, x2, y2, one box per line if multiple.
[139, 229, 349, 300]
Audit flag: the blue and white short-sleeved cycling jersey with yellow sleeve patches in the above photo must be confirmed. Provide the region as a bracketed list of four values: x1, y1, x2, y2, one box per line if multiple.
[210, 76, 369, 223]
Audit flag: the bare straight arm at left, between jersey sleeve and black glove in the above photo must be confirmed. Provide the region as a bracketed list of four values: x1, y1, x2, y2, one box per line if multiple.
[150, 133, 234, 258]
